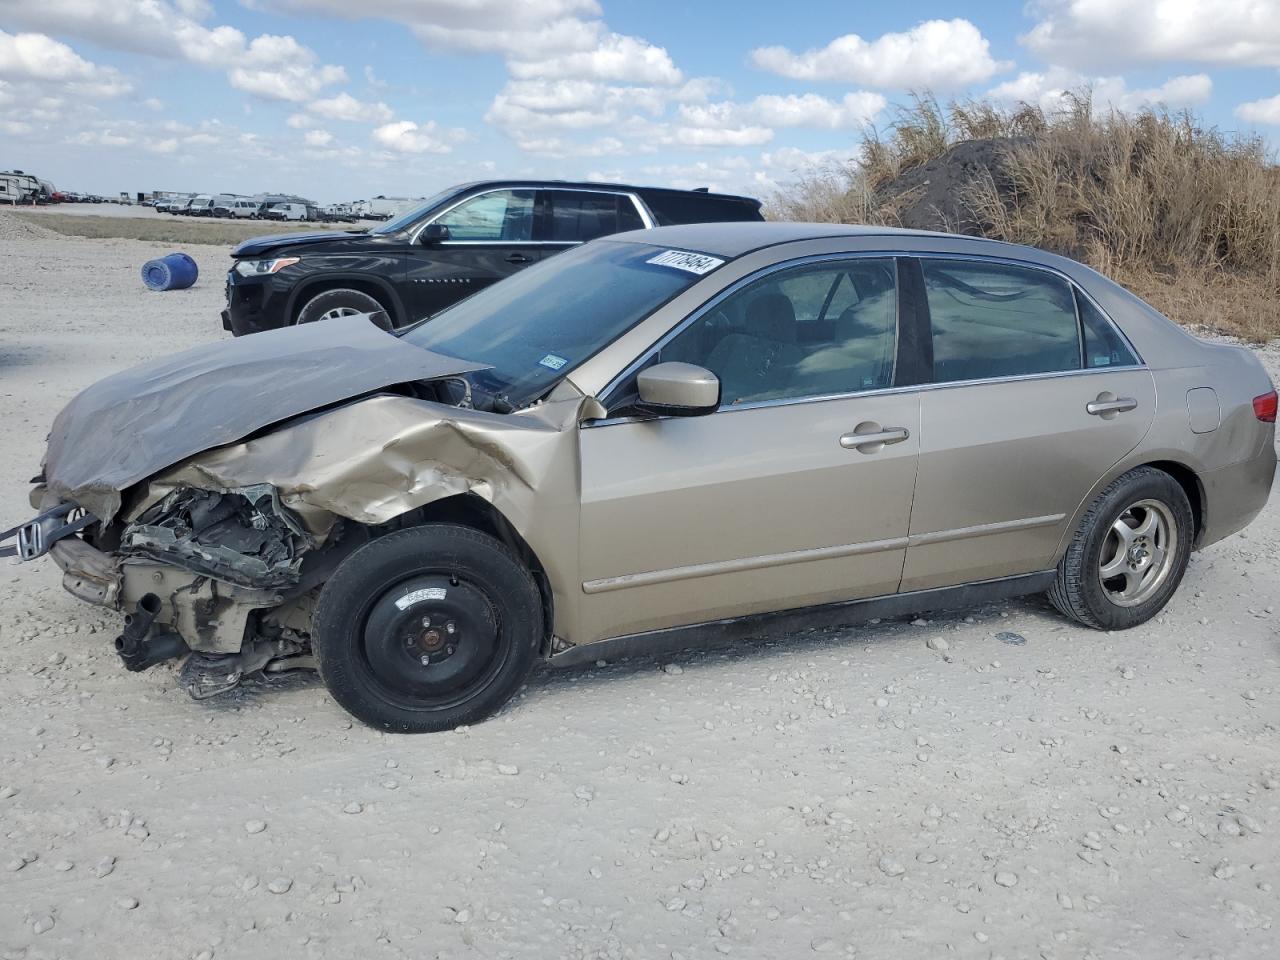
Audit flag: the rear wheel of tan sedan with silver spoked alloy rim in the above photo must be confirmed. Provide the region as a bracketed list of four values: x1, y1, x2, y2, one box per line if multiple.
[1048, 467, 1196, 630]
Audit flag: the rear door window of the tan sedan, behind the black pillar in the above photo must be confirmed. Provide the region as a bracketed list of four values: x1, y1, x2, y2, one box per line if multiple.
[920, 259, 1082, 383]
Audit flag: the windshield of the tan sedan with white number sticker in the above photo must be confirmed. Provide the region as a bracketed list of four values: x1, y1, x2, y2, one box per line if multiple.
[404, 241, 722, 410]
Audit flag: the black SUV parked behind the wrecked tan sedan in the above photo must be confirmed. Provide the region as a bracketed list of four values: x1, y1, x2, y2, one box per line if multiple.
[223, 180, 764, 337]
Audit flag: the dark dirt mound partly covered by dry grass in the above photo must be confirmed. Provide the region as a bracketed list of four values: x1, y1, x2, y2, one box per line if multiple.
[876, 137, 1028, 237]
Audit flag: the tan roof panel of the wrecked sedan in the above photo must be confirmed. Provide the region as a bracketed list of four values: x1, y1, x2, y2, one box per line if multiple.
[609, 220, 1029, 259]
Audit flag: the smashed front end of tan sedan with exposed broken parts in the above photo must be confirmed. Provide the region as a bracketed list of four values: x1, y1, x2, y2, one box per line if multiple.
[32, 484, 343, 699]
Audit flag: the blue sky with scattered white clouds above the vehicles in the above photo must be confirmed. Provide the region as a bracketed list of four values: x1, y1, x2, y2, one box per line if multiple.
[0, 0, 1280, 202]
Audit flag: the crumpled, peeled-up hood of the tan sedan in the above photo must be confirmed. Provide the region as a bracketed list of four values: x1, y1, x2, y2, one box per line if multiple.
[45, 315, 484, 521]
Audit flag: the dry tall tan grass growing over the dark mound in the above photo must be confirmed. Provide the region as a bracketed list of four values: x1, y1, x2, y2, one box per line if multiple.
[771, 93, 1280, 339]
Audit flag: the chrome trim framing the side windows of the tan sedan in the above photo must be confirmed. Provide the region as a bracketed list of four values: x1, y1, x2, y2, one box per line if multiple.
[580, 250, 1147, 428]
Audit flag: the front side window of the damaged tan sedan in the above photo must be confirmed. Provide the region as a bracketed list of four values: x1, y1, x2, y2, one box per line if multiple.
[657, 259, 897, 406]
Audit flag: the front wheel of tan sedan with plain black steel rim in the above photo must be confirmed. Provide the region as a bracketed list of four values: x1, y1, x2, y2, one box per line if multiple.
[311, 524, 543, 733]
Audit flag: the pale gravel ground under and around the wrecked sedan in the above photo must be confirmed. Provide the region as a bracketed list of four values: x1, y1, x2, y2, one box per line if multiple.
[0, 215, 1280, 960]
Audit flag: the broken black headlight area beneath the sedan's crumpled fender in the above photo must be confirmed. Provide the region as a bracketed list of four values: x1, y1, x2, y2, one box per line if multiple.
[120, 484, 316, 589]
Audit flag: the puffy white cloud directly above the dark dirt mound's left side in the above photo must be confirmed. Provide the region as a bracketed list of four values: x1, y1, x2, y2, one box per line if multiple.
[751, 19, 1005, 90]
